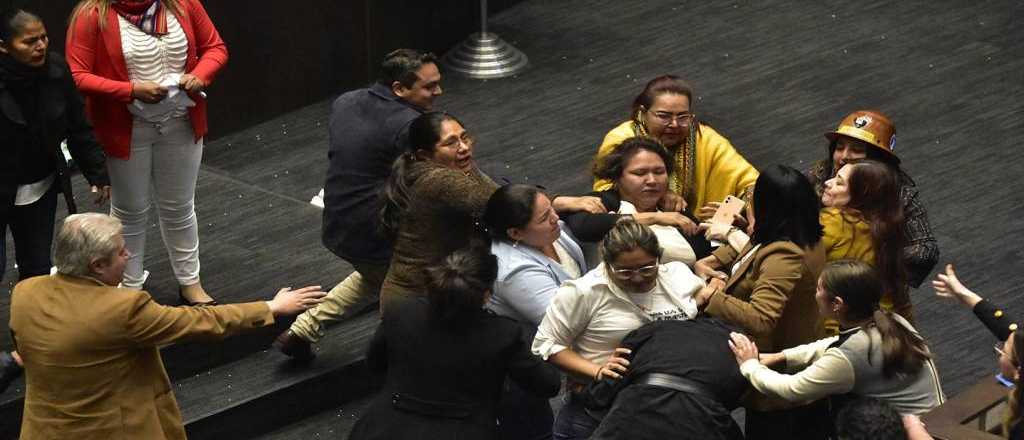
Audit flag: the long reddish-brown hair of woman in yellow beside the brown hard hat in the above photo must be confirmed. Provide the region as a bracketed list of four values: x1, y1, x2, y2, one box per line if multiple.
[845, 160, 908, 301]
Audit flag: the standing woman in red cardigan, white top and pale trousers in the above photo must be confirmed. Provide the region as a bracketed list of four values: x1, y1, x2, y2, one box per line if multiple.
[66, 0, 227, 305]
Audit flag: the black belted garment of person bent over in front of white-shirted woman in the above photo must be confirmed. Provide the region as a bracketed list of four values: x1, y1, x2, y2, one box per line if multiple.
[582, 316, 750, 440]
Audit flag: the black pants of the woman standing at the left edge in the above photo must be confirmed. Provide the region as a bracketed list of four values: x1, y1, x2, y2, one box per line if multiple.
[0, 181, 59, 280]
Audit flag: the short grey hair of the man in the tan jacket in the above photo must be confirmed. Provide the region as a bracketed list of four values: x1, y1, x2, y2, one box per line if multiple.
[53, 213, 122, 276]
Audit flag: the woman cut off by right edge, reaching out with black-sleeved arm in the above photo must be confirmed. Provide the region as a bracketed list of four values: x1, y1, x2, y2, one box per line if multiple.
[932, 264, 1024, 440]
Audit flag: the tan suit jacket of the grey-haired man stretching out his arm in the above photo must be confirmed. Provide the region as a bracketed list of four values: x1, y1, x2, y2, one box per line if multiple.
[10, 274, 273, 440]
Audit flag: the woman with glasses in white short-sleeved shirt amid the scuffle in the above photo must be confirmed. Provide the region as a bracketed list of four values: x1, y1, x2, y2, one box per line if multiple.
[534, 218, 720, 439]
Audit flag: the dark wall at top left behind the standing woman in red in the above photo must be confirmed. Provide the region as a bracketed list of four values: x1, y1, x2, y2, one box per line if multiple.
[0, 0, 521, 137]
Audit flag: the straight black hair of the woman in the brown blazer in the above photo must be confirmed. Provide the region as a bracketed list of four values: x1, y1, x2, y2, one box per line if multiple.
[751, 165, 824, 249]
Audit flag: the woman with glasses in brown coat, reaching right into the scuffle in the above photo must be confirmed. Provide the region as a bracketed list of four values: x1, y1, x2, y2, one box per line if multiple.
[381, 112, 598, 313]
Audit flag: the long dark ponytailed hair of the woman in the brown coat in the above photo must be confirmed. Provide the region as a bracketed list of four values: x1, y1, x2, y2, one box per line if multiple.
[380, 112, 462, 237]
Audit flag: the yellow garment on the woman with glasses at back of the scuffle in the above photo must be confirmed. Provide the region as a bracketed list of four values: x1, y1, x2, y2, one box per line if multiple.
[594, 121, 759, 212]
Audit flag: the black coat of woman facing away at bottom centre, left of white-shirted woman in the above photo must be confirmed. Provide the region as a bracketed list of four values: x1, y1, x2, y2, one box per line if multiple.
[348, 297, 561, 440]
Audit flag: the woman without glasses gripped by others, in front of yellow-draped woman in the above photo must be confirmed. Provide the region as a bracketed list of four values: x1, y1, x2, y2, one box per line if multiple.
[565, 136, 711, 261]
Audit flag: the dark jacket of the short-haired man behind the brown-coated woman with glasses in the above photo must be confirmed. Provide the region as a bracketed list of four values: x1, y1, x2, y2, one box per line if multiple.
[322, 84, 422, 265]
